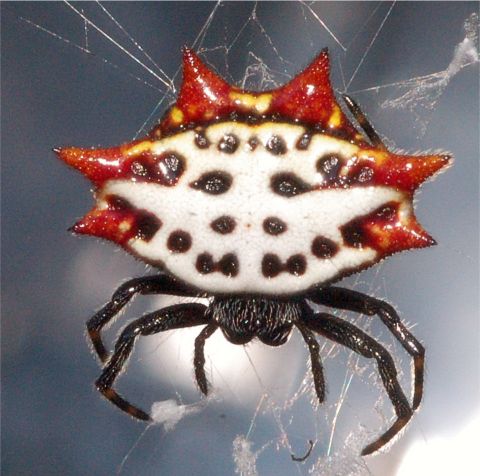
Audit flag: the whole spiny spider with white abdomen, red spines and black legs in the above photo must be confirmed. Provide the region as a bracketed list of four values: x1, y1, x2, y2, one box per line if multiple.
[55, 48, 450, 455]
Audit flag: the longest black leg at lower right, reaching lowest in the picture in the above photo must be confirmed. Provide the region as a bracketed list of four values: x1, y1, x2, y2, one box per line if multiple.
[301, 313, 413, 456]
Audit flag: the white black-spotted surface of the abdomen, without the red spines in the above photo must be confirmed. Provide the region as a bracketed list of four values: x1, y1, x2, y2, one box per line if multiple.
[97, 122, 411, 295]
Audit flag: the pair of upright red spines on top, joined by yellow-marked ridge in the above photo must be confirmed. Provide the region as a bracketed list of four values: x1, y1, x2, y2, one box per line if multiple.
[154, 48, 361, 140]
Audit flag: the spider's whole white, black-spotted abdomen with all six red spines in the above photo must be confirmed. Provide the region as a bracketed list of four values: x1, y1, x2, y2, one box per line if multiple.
[58, 50, 448, 296]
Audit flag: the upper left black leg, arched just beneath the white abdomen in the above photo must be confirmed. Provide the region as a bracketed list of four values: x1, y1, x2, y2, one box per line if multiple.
[87, 274, 201, 362]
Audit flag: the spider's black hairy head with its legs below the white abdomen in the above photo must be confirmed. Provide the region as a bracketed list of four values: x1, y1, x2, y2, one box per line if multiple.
[87, 274, 425, 456]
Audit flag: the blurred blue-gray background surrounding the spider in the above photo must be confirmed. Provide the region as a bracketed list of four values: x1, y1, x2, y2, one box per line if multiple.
[1, 2, 480, 476]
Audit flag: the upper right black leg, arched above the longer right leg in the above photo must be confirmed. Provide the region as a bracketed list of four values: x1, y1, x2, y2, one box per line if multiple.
[308, 286, 425, 410]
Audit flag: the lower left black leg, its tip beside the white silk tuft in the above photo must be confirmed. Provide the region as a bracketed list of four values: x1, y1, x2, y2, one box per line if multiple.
[95, 303, 208, 421]
